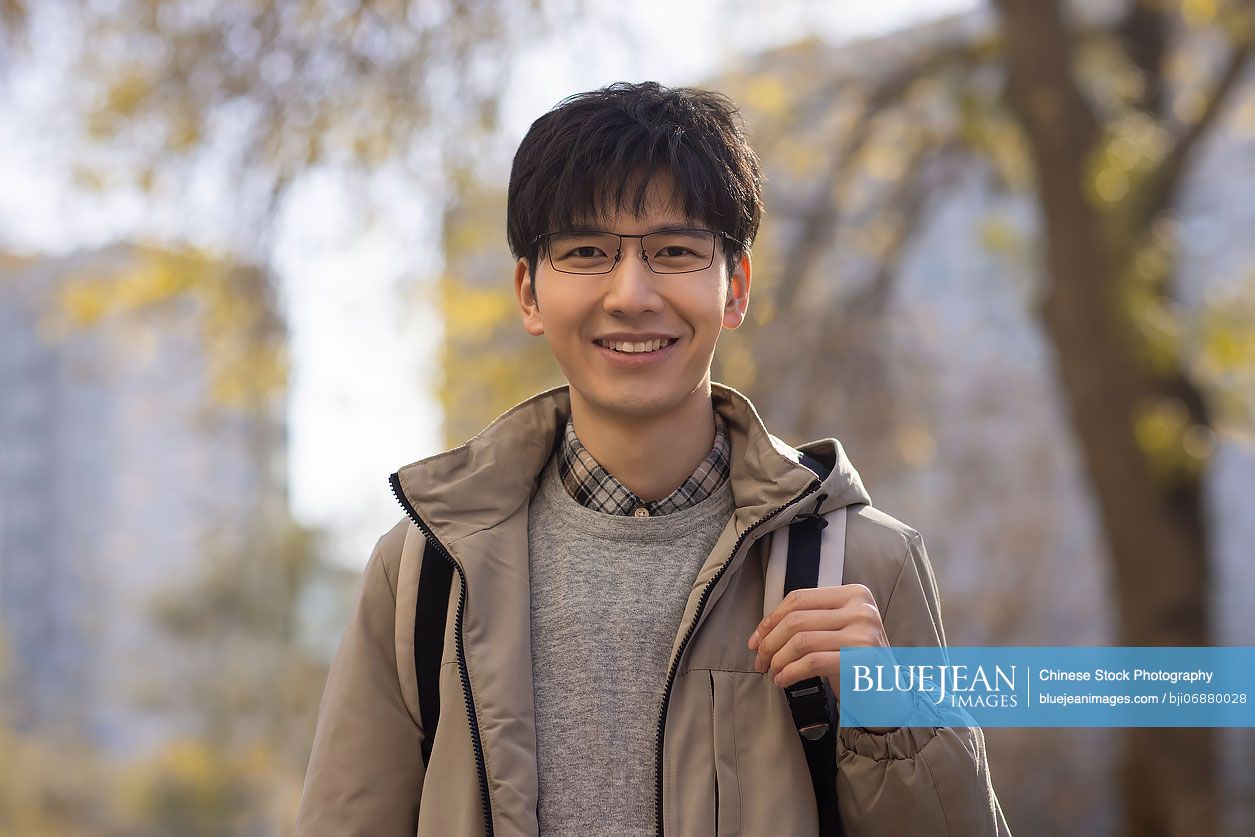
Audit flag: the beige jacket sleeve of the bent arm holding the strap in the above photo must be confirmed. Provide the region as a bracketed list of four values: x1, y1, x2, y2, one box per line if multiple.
[837, 535, 1010, 837]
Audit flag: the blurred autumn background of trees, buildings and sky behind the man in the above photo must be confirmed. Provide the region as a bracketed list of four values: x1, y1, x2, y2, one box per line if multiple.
[0, 0, 1255, 836]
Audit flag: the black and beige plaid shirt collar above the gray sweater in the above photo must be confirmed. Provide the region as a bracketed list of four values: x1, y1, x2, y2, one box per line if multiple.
[557, 413, 732, 517]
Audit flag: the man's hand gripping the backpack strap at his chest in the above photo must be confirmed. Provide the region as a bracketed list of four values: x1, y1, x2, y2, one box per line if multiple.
[749, 585, 889, 694]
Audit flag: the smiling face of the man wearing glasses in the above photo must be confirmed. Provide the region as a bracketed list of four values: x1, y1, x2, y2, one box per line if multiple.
[515, 174, 750, 426]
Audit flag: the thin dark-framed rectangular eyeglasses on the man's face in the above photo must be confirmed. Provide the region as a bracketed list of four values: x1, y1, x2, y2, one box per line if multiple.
[532, 230, 743, 274]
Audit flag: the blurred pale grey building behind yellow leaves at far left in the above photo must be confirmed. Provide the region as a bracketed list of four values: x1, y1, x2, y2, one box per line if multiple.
[0, 245, 286, 753]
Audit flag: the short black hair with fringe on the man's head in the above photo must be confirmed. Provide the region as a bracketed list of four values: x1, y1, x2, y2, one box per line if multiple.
[506, 82, 763, 282]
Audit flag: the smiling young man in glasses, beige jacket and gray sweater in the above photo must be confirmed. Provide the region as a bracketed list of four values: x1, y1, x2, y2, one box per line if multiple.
[297, 83, 1009, 837]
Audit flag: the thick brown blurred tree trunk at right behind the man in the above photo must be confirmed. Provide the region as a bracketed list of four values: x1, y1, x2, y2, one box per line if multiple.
[998, 0, 1219, 837]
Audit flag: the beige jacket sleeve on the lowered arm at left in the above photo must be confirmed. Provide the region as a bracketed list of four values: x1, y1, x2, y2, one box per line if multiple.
[296, 536, 425, 837]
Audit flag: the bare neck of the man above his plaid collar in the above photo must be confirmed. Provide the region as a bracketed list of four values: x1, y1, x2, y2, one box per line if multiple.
[570, 381, 714, 501]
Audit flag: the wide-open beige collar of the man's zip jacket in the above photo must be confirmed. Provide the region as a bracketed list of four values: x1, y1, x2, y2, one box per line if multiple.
[394, 381, 871, 545]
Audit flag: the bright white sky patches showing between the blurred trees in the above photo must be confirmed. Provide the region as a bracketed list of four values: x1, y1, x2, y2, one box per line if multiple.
[0, 0, 979, 566]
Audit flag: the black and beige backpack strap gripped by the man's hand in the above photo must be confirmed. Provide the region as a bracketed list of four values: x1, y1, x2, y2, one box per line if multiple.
[763, 453, 846, 837]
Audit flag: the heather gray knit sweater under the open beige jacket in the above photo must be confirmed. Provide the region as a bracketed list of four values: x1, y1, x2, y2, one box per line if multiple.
[527, 458, 734, 837]
